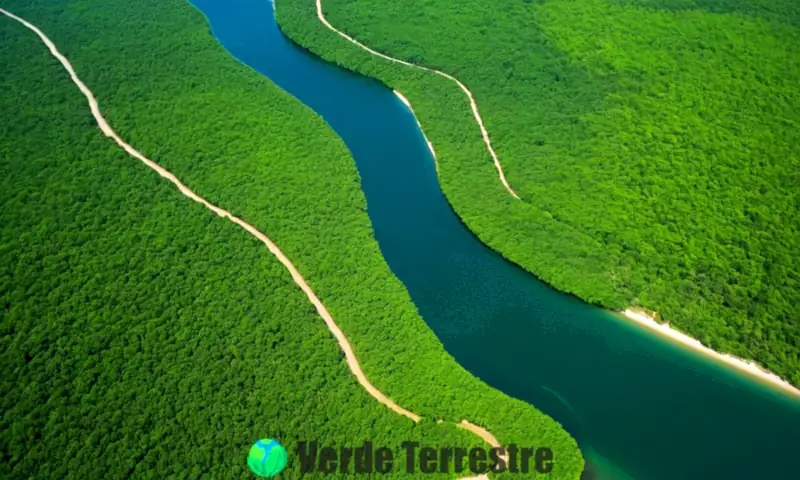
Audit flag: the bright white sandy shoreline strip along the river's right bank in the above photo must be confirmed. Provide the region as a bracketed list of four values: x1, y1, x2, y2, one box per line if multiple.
[619, 307, 800, 398]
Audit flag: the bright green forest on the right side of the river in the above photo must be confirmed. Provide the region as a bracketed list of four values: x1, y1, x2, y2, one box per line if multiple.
[276, 0, 800, 385]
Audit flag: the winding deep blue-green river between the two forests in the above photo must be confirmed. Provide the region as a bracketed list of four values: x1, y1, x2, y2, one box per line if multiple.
[193, 0, 800, 480]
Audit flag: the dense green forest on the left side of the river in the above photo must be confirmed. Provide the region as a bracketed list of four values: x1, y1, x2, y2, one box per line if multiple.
[0, 0, 583, 480]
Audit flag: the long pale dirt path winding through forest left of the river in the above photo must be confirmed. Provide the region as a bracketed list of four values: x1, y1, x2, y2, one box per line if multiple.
[0, 8, 507, 480]
